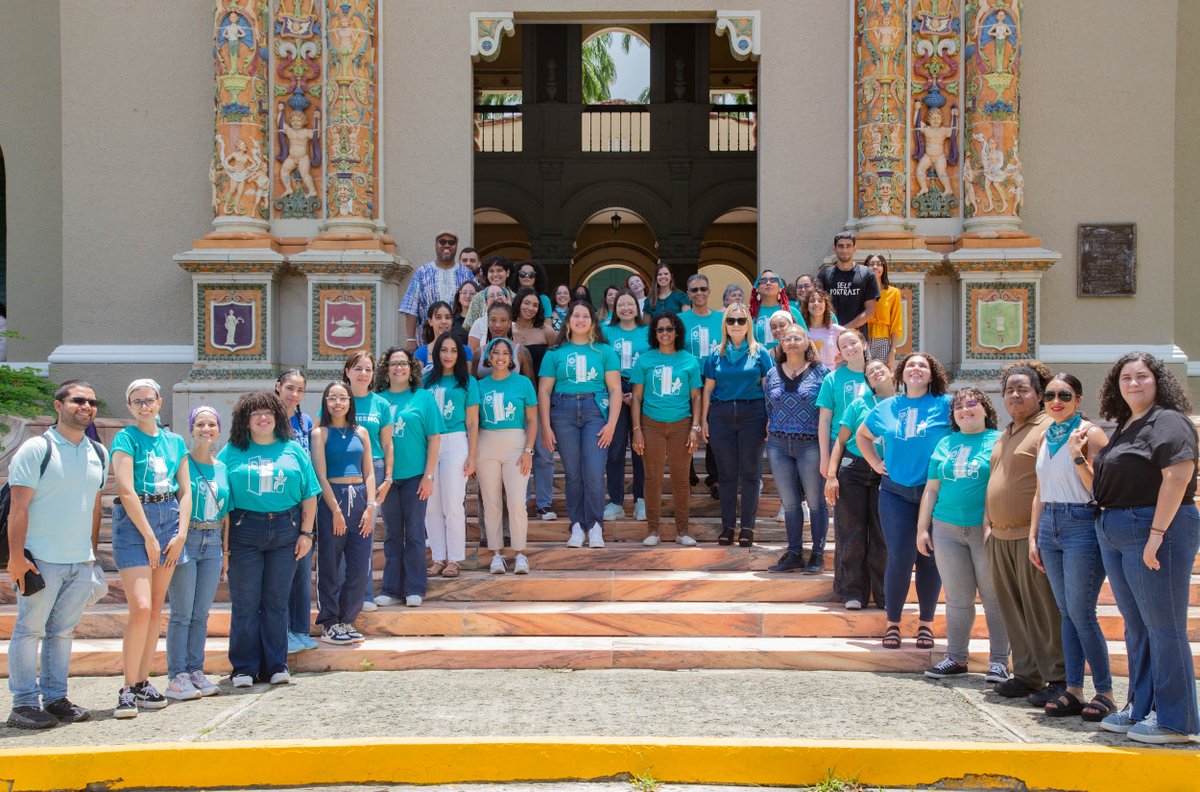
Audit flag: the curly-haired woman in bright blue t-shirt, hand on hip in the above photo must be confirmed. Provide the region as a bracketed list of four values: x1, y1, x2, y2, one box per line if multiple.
[854, 353, 950, 649]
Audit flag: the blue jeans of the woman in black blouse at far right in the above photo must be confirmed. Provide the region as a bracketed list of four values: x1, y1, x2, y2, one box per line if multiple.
[1096, 504, 1200, 734]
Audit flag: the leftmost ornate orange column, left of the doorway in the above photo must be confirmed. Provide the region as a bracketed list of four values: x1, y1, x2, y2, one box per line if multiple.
[209, 0, 271, 239]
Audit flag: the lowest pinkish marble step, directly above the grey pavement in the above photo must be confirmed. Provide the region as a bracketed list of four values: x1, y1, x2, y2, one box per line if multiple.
[0, 636, 1185, 683]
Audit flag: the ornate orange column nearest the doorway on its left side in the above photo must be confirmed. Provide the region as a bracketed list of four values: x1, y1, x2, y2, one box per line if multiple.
[325, 0, 379, 239]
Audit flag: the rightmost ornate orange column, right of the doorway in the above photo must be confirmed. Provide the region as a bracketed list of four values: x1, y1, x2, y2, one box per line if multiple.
[962, 0, 1026, 239]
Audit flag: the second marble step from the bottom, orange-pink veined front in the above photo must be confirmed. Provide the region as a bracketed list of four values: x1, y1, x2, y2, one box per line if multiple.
[0, 601, 1200, 641]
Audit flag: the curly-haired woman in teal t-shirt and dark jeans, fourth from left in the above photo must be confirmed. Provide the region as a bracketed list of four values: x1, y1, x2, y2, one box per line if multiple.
[217, 391, 320, 688]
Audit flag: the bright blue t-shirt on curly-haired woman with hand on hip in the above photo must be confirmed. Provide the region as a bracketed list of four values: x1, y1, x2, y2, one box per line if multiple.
[865, 394, 950, 487]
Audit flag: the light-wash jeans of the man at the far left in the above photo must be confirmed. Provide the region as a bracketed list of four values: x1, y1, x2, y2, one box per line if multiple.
[8, 558, 91, 709]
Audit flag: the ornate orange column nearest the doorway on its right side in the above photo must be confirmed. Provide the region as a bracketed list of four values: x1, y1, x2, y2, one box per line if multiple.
[852, 0, 911, 239]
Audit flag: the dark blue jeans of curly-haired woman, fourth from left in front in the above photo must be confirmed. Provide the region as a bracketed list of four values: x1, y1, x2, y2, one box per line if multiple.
[229, 505, 300, 679]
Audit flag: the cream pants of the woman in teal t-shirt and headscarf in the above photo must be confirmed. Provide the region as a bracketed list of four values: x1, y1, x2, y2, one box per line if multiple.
[475, 430, 529, 553]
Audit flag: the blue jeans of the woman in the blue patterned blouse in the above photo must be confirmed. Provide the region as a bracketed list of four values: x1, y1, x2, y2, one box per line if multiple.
[768, 430, 829, 553]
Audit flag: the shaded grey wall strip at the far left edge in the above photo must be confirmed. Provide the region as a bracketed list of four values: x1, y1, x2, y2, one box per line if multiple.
[0, 0, 62, 362]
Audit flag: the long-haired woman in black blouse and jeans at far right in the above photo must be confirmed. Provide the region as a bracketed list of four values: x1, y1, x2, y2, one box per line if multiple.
[1084, 352, 1200, 745]
